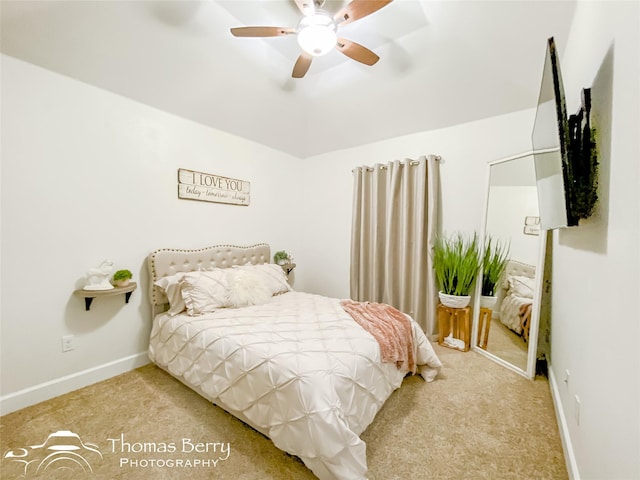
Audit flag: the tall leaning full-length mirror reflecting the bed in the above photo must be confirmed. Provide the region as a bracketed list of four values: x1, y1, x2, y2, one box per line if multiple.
[474, 153, 546, 378]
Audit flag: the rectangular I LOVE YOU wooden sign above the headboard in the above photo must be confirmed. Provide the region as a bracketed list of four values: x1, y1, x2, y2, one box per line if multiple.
[178, 168, 251, 205]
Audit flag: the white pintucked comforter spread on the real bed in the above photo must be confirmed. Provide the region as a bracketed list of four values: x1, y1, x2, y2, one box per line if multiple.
[149, 292, 441, 480]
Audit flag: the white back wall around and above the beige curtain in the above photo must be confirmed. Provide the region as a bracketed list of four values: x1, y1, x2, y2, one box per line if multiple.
[296, 110, 542, 298]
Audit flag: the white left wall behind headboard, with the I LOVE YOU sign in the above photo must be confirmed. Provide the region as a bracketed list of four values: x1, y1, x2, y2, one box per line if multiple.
[0, 56, 301, 412]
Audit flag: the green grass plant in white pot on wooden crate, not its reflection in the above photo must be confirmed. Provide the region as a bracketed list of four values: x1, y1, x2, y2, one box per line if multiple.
[433, 232, 481, 308]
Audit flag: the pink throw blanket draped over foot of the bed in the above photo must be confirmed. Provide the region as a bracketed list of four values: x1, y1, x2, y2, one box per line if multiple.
[340, 300, 416, 373]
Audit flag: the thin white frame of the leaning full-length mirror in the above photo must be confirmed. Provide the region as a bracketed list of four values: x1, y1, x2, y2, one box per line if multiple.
[471, 149, 554, 379]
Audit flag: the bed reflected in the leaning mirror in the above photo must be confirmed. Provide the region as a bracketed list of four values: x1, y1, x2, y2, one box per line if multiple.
[494, 260, 536, 341]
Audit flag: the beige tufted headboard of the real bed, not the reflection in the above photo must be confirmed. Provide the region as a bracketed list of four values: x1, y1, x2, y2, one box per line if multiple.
[147, 243, 271, 313]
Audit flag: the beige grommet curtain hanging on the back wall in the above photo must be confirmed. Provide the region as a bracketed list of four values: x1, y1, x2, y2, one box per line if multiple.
[350, 155, 439, 335]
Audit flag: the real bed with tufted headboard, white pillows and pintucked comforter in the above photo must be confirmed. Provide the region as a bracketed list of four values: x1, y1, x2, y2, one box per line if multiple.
[148, 244, 441, 480]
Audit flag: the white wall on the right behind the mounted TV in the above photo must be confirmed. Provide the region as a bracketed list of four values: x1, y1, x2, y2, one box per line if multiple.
[551, 1, 640, 480]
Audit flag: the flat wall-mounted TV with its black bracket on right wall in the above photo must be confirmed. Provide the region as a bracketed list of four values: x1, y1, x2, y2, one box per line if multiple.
[531, 37, 597, 230]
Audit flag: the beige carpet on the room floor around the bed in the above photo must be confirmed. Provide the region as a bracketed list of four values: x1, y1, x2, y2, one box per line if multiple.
[0, 345, 568, 480]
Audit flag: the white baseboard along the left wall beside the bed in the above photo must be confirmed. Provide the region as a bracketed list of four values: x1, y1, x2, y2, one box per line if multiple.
[0, 352, 149, 415]
